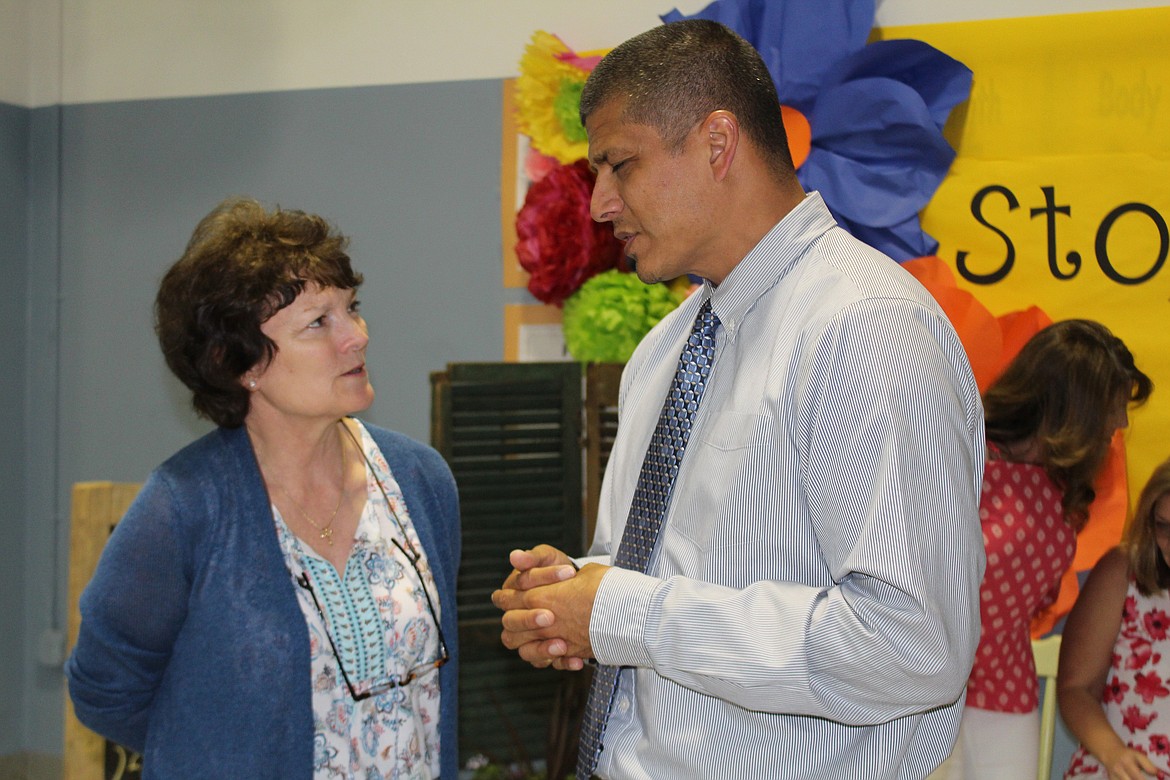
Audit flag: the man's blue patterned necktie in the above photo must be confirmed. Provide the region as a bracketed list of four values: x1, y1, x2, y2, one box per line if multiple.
[577, 301, 720, 780]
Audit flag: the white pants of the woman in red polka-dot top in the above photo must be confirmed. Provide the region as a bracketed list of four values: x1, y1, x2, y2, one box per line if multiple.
[929, 706, 1040, 780]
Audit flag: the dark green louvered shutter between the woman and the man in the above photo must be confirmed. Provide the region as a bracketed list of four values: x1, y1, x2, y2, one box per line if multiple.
[432, 363, 584, 765]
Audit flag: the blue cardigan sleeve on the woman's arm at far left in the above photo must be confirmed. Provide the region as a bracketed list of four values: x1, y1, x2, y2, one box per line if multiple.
[66, 472, 191, 751]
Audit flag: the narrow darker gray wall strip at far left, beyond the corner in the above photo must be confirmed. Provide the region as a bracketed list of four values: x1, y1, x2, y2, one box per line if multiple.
[0, 103, 30, 755]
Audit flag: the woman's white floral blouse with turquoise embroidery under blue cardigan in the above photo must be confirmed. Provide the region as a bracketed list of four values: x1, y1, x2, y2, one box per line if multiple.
[273, 422, 442, 780]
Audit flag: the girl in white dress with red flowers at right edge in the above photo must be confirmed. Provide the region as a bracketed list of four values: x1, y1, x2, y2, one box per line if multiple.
[1058, 461, 1170, 780]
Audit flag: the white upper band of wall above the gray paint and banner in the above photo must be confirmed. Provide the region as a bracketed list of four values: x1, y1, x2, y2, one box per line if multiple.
[0, 0, 1168, 106]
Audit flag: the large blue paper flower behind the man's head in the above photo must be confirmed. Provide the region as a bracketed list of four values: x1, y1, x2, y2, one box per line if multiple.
[661, 0, 971, 262]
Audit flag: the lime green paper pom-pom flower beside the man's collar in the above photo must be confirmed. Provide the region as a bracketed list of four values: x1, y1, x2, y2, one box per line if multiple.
[562, 269, 686, 363]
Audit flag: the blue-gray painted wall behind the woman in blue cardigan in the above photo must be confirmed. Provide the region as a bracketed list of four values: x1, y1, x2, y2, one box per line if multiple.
[17, 81, 531, 753]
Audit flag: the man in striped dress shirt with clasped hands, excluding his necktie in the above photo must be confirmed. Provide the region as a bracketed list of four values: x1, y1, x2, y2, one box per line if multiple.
[493, 21, 984, 780]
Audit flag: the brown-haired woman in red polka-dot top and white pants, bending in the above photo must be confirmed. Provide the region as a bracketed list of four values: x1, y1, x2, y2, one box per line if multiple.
[931, 319, 1152, 780]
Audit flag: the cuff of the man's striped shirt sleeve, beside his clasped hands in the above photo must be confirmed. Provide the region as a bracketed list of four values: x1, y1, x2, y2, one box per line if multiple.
[589, 567, 663, 667]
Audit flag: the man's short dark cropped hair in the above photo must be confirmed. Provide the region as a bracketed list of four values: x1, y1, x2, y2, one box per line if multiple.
[580, 19, 793, 173]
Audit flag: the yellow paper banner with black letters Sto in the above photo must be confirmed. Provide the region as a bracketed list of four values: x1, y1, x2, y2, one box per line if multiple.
[876, 8, 1170, 496]
